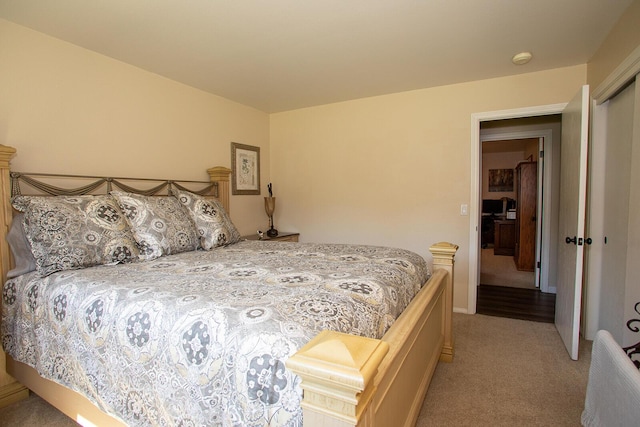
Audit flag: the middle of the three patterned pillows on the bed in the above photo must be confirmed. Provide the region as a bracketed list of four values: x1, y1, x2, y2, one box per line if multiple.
[111, 191, 198, 260]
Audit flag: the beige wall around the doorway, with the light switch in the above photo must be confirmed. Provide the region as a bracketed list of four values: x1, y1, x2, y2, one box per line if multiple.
[270, 65, 586, 310]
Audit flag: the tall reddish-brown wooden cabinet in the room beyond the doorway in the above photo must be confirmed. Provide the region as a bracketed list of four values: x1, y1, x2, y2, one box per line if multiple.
[513, 162, 538, 271]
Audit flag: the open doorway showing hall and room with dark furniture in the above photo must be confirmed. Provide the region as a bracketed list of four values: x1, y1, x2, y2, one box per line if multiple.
[476, 115, 561, 322]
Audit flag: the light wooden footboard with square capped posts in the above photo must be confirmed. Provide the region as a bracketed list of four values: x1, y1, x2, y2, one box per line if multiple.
[286, 243, 458, 427]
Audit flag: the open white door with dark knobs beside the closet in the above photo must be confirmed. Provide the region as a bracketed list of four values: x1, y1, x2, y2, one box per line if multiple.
[556, 85, 589, 360]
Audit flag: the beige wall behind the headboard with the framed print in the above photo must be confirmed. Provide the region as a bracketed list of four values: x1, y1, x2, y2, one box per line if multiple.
[0, 19, 270, 233]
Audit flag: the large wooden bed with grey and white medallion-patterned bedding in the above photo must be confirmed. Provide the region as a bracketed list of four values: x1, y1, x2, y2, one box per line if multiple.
[0, 146, 457, 426]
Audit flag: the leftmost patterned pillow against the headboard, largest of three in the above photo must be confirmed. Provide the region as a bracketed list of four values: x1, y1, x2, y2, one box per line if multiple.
[12, 195, 138, 277]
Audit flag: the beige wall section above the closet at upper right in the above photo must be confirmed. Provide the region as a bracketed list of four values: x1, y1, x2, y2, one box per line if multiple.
[587, 0, 640, 90]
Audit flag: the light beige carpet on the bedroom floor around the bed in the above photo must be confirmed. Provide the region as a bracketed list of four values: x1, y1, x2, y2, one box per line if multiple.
[0, 313, 591, 427]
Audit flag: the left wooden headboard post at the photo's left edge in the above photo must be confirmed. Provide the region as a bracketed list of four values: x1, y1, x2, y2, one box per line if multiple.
[0, 144, 29, 408]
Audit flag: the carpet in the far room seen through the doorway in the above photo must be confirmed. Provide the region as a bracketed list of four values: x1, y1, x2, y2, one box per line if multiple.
[480, 248, 536, 289]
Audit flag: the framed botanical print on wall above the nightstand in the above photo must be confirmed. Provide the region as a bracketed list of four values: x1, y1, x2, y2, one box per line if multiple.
[231, 142, 260, 195]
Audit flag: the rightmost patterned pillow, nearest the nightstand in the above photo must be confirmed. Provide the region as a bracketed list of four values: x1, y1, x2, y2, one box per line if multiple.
[171, 188, 240, 251]
